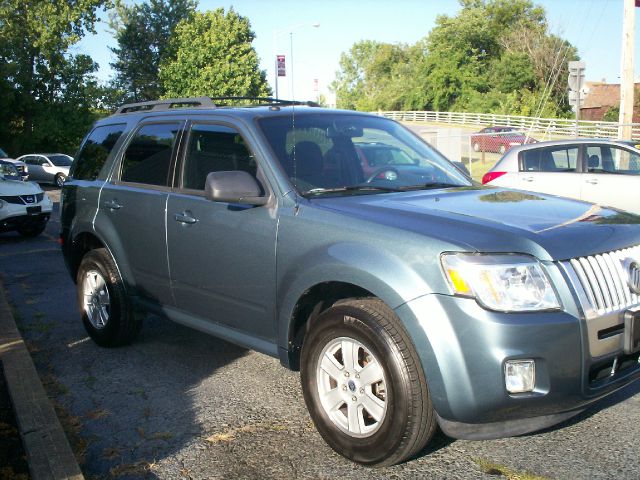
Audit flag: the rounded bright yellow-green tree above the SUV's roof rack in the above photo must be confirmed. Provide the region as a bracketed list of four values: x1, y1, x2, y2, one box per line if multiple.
[160, 8, 271, 97]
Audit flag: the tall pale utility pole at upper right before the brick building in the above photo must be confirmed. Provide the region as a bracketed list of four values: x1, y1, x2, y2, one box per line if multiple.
[618, 0, 636, 140]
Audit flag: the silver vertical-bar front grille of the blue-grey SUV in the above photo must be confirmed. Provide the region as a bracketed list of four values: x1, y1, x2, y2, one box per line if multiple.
[562, 245, 640, 314]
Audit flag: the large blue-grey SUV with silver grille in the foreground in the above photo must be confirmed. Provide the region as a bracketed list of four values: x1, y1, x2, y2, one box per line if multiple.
[60, 95, 640, 466]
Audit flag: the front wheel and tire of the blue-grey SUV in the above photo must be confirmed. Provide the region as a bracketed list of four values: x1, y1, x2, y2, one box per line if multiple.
[301, 298, 437, 467]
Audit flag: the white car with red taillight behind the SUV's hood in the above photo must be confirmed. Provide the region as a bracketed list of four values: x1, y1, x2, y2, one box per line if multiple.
[482, 139, 640, 214]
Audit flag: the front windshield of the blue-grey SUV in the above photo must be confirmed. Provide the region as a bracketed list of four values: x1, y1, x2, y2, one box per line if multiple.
[258, 112, 471, 196]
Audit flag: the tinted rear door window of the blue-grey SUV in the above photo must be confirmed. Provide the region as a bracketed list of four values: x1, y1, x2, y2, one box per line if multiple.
[120, 122, 182, 186]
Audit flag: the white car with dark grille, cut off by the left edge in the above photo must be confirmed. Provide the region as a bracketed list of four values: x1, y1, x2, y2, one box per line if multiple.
[0, 160, 53, 237]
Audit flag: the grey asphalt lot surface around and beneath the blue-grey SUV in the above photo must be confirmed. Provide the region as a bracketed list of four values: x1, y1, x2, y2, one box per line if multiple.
[0, 190, 640, 480]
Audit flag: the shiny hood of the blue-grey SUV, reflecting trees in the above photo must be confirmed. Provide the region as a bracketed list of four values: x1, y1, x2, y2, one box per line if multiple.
[311, 187, 640, 260]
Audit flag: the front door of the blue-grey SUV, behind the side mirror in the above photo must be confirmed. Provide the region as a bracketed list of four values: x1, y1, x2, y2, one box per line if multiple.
[167, 121, 278, 348]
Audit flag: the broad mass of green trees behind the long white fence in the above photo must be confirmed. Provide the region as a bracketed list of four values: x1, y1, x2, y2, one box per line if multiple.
[332, 0, 577, 116]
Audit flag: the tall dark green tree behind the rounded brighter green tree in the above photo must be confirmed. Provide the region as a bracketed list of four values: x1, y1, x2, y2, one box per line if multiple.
[109, 0, 197, 103]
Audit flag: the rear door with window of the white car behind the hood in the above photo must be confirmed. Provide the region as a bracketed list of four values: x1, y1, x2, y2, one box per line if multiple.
[516, 145, 581, 200]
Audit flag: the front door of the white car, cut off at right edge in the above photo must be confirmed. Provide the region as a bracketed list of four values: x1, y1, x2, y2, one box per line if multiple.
[581, 144, 640, 214]
